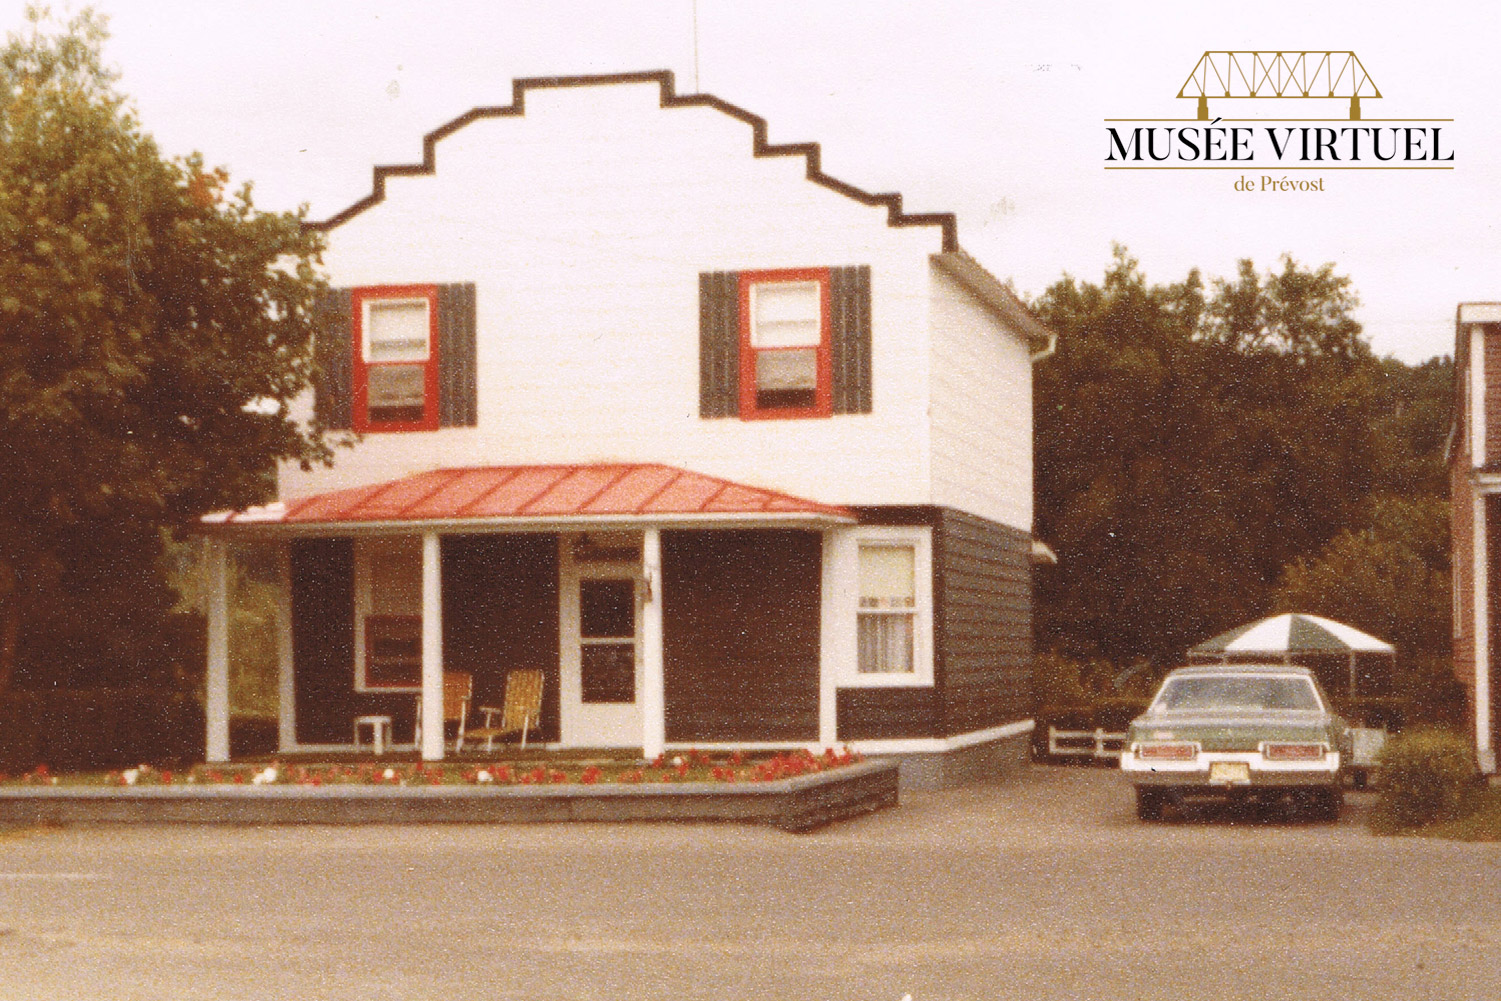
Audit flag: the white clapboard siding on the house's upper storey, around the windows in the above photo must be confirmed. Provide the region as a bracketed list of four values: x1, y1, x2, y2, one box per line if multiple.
[282, 83, 1030, 525]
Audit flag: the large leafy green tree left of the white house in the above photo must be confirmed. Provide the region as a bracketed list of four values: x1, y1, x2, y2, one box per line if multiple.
[0, 11, 327, 686]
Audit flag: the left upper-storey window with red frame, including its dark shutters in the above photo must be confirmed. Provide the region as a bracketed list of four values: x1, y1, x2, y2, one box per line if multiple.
[314, 282, 479, 434]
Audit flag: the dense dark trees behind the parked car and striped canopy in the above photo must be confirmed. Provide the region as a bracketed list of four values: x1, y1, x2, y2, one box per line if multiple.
[1034, 249, 1447, 663]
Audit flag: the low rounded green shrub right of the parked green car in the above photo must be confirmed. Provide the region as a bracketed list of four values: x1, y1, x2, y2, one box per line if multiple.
[1370, 726, 1480, 834]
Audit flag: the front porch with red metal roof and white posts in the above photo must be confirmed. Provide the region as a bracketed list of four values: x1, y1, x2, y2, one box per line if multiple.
[204, 467, 854, 762]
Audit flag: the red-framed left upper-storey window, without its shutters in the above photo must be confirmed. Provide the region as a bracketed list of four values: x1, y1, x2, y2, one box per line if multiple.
[353, 285, 438, 431]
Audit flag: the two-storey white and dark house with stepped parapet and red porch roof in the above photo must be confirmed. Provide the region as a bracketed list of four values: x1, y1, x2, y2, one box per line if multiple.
[206, 72, 1052, 782]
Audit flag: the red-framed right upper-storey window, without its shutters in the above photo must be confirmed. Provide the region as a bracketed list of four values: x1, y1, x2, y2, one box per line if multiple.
[740, 269, 833, 417]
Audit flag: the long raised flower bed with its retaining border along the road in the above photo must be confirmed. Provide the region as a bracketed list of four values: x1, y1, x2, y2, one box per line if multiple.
[0, 752, 898, 831]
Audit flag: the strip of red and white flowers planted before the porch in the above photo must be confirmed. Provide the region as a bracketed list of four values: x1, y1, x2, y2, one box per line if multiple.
[0, 747, 862, 786]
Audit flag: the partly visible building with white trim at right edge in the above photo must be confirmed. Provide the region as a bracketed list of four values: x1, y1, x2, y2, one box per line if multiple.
[1448, 303, 1501, 773]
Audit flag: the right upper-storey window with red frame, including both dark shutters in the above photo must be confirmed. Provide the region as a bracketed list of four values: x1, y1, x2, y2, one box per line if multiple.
[698, 267, 871, 420]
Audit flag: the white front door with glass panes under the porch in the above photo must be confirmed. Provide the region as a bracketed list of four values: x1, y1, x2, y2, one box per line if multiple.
[558, 533, 641, 747]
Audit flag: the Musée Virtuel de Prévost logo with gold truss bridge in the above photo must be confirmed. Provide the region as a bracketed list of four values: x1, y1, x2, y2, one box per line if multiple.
[1105, 50, 1454, 180]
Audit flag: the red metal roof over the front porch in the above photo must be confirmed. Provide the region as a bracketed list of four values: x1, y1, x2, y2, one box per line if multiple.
[201, 462, 856, 533]
